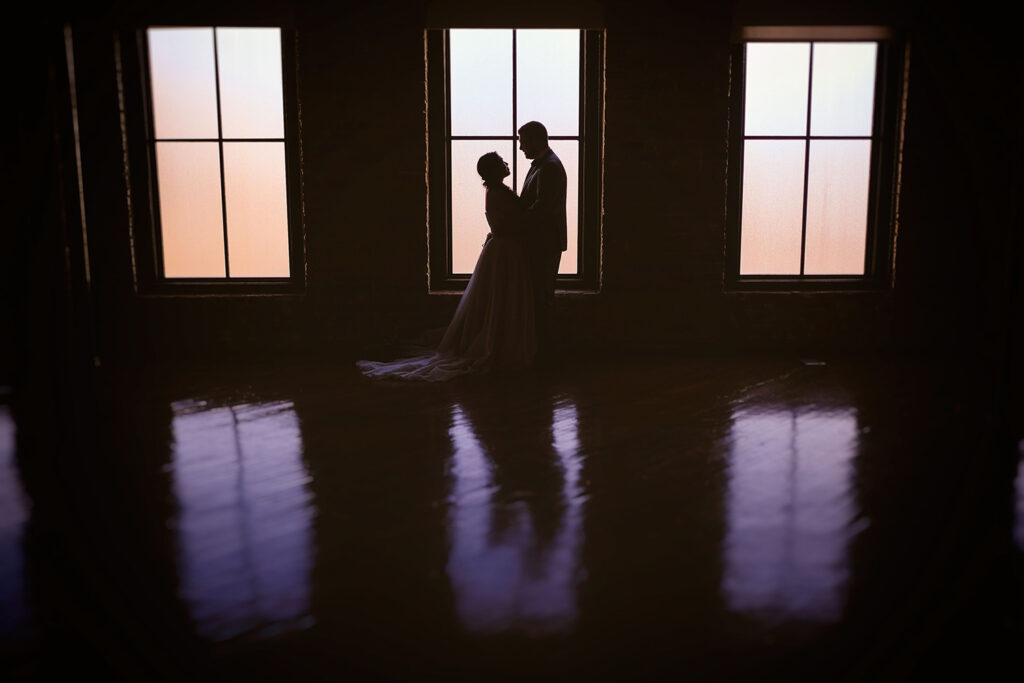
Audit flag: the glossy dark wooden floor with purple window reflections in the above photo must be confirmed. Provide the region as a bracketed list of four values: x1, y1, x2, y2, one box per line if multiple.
[0, 355, 1024, 681]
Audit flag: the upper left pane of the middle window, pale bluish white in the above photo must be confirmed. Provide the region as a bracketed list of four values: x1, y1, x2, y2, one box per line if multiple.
[449, 29, 513, 136]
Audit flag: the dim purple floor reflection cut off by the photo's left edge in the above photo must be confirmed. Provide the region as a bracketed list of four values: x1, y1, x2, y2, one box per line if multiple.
[0, 405, 30, 639]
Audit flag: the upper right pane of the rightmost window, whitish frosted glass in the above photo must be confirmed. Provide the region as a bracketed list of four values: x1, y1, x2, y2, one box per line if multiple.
[811, 43, 878, 135]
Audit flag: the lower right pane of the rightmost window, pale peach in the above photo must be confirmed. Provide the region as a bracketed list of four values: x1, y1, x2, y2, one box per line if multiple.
[804, 140, 871, 275]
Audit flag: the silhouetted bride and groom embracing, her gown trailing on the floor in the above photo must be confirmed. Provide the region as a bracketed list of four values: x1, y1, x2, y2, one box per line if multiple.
[356, 121, 567, 382]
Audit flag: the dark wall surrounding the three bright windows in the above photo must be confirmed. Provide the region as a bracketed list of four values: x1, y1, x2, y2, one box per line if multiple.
[14, 0, 1021, 368]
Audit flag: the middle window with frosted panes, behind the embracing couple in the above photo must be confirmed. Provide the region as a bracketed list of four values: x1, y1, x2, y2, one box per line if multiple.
[427, 29, 602, 291]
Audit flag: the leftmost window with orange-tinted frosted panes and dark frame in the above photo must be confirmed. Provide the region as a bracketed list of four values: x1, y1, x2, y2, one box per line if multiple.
[121, 27, 303, 293]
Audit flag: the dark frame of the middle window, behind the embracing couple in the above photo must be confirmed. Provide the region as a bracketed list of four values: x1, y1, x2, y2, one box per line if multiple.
[425, 27, 604, 293]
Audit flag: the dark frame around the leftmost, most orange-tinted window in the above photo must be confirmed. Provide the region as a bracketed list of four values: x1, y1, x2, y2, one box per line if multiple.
[116, 23, 306, 296]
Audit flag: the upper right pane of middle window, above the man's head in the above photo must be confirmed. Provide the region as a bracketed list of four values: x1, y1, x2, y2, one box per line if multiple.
[516, 30, 580, 135]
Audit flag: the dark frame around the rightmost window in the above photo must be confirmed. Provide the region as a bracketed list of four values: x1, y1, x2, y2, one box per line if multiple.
[723, 27, 907, 292]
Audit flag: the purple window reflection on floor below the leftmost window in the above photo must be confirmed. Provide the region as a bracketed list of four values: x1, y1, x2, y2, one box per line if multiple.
[172, 401, 314, 640]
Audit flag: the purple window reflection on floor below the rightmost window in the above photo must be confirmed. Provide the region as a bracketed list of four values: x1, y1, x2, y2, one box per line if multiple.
[722, 408, 858, 622]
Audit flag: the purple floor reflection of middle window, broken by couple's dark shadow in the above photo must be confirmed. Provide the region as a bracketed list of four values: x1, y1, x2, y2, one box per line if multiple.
[447, 399, 584, 635]
